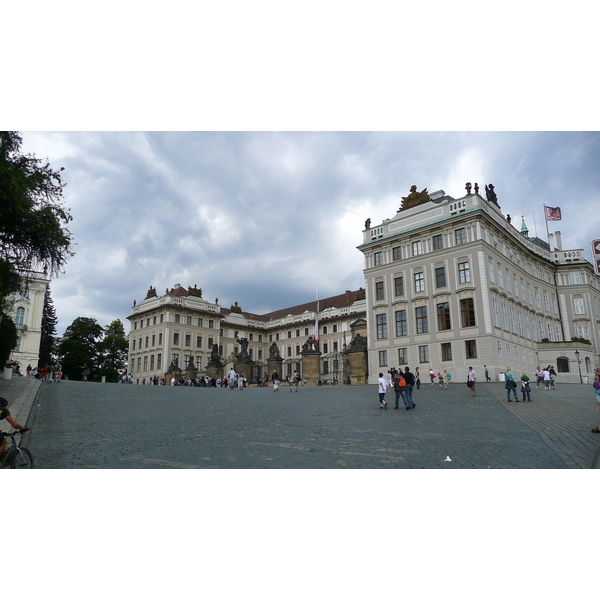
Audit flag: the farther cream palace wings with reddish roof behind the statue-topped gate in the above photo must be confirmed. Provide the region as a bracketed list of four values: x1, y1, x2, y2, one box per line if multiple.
[127, 284, 366, 383]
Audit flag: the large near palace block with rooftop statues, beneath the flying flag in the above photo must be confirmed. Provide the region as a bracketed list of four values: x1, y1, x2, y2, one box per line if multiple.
[358, 183, 600, 383]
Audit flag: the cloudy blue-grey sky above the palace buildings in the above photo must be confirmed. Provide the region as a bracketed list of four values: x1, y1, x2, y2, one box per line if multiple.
[17, 132, 600, 331]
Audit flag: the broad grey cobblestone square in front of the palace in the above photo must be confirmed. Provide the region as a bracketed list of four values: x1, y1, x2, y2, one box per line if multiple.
[19, 381, 600, 469]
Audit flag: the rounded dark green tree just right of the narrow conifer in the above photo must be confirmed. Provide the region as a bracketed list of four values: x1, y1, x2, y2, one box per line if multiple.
[57, 317, 104, 381]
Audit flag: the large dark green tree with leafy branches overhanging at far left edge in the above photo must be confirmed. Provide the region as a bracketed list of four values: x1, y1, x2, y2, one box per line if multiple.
[0, 131, 73, 307]
